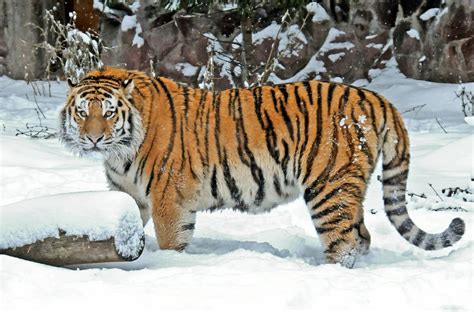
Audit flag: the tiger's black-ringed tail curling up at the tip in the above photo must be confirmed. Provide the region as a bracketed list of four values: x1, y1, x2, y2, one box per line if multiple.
[382, 105, 465, 250]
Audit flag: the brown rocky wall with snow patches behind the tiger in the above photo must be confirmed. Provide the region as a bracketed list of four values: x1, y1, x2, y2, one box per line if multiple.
[0, 0, 474, 85]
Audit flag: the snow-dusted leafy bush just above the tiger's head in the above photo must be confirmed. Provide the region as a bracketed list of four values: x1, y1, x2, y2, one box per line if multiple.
[33, 8, 106, 82]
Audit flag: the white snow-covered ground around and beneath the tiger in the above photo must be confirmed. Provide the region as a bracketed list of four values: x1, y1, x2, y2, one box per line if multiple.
[0, 64, 474, 311]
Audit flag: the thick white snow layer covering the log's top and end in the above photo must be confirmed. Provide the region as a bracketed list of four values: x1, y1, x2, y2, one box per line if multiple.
[0, 191, 143, 257]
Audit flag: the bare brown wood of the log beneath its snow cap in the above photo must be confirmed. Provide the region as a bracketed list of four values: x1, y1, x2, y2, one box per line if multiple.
[0, 231, 145, 266]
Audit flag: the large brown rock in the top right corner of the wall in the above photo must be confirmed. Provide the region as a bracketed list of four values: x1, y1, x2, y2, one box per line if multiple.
[393, 0, 474, 83]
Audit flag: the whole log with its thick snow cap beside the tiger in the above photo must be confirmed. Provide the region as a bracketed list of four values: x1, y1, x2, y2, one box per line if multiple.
[0, 192, 145, 266]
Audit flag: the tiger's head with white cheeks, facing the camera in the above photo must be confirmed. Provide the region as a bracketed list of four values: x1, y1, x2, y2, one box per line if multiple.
[59, 75, 144, 160]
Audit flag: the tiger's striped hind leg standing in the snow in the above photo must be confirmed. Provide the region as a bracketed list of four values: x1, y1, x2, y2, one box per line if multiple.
[305, 177, 370, 268]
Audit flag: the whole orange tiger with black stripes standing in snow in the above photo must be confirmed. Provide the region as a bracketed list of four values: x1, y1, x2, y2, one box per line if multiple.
[60, 67, 465, 268]
